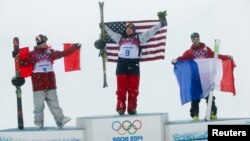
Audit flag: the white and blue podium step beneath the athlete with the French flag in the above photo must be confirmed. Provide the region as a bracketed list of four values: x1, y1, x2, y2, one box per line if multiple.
[165, 118, 250, 141]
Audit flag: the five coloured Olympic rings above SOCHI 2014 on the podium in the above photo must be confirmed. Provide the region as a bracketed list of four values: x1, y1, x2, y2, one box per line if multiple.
[112, 120, 142, 135]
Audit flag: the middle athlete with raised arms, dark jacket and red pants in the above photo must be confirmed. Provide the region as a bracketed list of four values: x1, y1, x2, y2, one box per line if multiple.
[105, 21, 164, 115]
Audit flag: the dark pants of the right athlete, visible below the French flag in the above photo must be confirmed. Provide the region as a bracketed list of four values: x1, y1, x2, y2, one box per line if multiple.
[190, 96, 217, 117]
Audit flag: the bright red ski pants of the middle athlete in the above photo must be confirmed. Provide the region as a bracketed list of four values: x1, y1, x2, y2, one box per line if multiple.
[116, 74, 140, 111]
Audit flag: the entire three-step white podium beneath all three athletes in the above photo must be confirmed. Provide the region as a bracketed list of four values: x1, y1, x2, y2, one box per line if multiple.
[0, 113, 250, 141]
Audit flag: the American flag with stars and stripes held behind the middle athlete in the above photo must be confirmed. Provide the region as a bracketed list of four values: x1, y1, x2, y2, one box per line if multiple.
[105, 20, 167, 62]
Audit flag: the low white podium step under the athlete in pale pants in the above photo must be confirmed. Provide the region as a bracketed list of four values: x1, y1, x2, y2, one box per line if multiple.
[0, 127, 87, 141]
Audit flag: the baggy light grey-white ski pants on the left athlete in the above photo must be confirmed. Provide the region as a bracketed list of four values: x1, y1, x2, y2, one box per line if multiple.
[33, 89, 64, 125]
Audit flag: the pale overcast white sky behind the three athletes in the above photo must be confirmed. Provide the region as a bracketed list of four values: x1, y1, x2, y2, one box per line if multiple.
[0, 0, 250, 129]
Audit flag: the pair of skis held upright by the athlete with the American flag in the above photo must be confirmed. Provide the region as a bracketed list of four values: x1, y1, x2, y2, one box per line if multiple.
[99, 2, 108, 88]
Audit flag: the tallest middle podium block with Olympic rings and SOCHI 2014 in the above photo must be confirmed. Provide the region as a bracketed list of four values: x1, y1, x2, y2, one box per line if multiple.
[76, 113, 168, 141]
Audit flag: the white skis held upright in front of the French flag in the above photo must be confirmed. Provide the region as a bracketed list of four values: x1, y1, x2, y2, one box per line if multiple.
[205, 39, 220, 121]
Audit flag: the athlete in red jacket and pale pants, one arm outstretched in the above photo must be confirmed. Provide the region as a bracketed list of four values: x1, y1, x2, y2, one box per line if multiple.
[20, 34, 81, 128]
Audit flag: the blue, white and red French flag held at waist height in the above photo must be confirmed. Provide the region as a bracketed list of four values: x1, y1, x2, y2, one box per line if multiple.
[174, 58, 236, 105]
